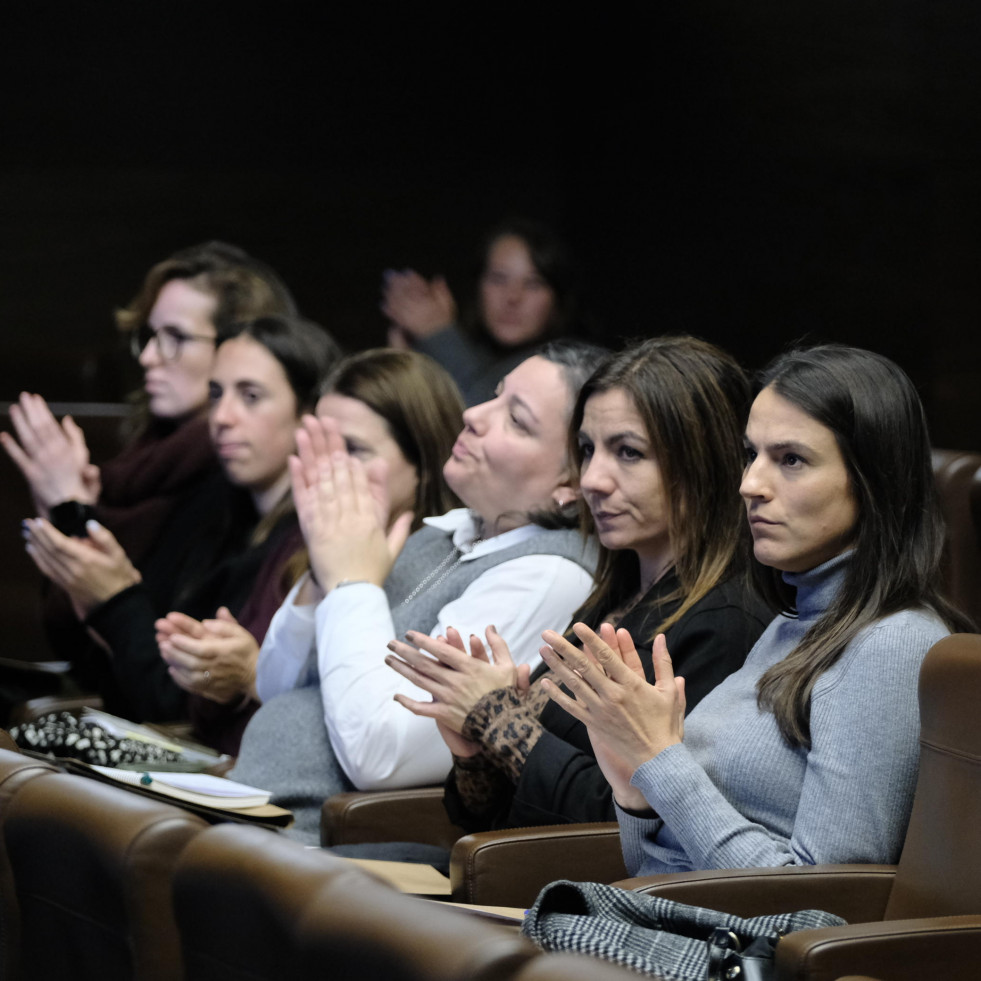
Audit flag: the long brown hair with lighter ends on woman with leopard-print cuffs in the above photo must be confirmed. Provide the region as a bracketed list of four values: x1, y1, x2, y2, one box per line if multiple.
[570, 336, 750, 644]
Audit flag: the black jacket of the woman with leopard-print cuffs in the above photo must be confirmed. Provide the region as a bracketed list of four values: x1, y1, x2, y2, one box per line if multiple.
[444, 575, 772, 831]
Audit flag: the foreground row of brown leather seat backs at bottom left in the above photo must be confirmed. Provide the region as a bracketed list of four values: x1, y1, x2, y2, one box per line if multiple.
[0, 749, 634, 981]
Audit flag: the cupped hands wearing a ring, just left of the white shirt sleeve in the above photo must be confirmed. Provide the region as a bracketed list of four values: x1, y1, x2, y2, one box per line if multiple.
[155, 606, 259, 703]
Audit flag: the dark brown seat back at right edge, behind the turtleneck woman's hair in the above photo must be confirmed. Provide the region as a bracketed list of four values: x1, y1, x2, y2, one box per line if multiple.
[933, 450, 981, 627]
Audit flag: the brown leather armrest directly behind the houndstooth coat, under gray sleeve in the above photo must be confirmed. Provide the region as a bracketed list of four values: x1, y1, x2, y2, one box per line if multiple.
[615, 865, 896, 923]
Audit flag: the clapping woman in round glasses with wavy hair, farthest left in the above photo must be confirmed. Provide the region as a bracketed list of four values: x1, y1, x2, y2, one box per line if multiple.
[0, 242, 295, 708]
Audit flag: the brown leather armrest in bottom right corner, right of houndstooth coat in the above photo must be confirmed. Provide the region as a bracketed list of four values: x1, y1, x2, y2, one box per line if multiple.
[776, 915, 981, 981]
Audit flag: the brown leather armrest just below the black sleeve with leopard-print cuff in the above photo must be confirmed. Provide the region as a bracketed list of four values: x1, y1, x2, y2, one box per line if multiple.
[450, 821, 625, 906]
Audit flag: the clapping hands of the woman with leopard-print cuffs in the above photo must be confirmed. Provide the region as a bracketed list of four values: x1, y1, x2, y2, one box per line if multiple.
[385, 626, 531, 736]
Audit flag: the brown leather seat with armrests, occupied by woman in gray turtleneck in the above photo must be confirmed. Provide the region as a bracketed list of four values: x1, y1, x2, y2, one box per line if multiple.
[619, 634, 981, 981]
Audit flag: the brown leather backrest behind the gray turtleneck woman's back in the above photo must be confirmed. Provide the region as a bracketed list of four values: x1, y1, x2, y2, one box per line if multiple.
[885, 634, 981, 920]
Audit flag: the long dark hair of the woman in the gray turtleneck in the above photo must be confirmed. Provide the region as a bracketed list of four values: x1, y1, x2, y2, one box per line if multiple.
[753, 344, 973, 747]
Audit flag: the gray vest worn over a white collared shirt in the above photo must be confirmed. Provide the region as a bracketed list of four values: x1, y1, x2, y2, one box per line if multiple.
[229, 525, 596, 843]
